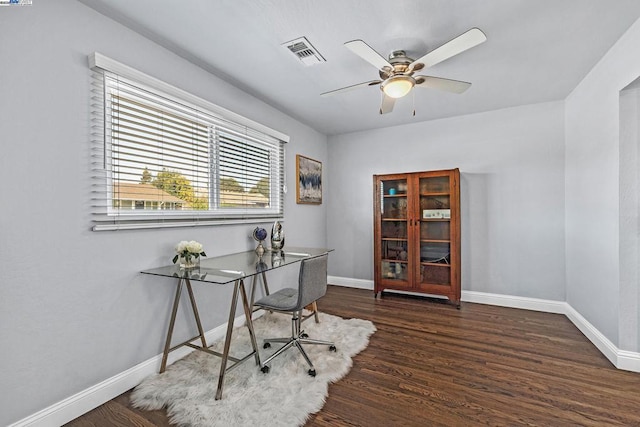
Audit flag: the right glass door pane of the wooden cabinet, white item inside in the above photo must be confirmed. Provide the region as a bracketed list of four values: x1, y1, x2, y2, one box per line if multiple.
[419, 176, 451, 286]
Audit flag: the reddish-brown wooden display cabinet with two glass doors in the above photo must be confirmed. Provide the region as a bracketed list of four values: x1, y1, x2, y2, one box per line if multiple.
[373, 169, 460, 308]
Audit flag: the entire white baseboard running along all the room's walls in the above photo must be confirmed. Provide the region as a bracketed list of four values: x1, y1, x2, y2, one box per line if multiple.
[9, 276, 640, 427]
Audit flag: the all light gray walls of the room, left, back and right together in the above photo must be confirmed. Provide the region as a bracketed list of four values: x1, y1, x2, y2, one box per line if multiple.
[0, 0, 640, 425]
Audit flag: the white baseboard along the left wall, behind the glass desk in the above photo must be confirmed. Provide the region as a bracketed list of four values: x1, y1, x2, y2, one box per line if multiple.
[9, 312, 255, 427]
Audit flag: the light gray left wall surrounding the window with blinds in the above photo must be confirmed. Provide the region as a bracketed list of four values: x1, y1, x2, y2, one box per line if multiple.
[0, 0, 332, 425]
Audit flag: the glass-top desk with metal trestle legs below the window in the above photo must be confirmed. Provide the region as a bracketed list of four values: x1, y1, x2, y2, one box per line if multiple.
[141, 248, 331, 400]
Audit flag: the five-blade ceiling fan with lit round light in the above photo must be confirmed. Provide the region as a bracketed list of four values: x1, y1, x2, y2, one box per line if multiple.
[320, 28, 487, 115]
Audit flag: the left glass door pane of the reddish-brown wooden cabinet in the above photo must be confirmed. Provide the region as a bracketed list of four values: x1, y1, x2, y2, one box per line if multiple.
[379, 179, 409, 281]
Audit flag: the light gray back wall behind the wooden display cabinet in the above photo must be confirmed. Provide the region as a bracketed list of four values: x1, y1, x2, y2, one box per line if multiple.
[326, 102, 565, 301]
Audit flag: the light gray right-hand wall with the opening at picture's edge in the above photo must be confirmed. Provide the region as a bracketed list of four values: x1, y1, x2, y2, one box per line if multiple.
[565, 16, 640, 351]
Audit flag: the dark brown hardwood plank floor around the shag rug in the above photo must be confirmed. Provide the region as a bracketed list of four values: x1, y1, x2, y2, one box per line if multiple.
[68, 286, 640, 427]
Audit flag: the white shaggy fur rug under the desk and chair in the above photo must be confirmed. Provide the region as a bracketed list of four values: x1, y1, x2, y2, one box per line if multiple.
[131, 313, 376, 427]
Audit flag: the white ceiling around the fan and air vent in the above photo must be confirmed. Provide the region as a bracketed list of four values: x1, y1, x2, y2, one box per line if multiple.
[80, 0, 640, 135]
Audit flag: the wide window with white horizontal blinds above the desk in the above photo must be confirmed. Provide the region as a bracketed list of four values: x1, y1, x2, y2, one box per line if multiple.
[90, 53, 288, 230]
